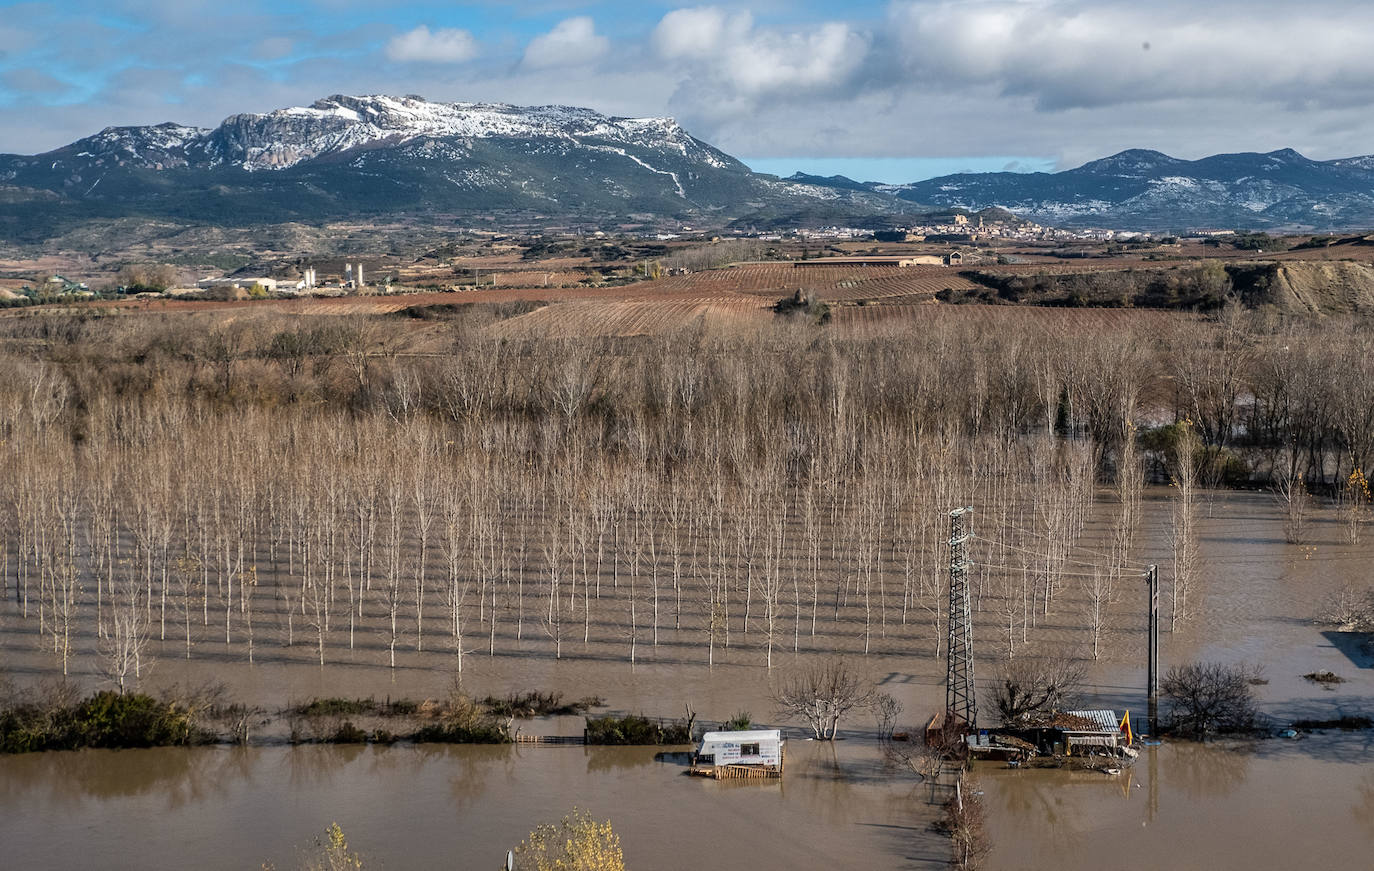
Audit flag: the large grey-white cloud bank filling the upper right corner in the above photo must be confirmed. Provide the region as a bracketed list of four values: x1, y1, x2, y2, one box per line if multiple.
[892, 0, 1374, 110]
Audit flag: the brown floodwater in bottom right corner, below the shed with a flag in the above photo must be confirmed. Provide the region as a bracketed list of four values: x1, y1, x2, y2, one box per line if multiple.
[978, 734, 1374, 871]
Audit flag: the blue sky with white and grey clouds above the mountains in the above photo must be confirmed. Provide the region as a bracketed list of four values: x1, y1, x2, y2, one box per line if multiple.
[0, 0, 1374, 181]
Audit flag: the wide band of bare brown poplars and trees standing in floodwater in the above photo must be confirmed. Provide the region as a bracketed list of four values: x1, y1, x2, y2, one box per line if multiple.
[0, 298, 1374, 686]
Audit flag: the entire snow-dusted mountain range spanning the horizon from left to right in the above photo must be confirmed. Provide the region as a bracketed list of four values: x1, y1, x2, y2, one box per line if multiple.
[0, 96, 1374, 239]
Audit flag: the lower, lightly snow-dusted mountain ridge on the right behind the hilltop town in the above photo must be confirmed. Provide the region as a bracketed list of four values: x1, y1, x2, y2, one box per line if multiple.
[866, 148, 1374, 229]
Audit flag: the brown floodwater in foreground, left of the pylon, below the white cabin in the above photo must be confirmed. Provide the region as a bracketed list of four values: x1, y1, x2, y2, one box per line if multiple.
[0, 740, 948, 871]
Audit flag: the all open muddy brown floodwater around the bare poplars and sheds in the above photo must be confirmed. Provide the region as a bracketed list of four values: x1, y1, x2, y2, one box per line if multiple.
[0, 490, 1374, 871]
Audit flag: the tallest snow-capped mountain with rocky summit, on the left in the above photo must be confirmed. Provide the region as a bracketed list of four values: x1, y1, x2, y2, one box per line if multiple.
[0, 96, 896, 234]
